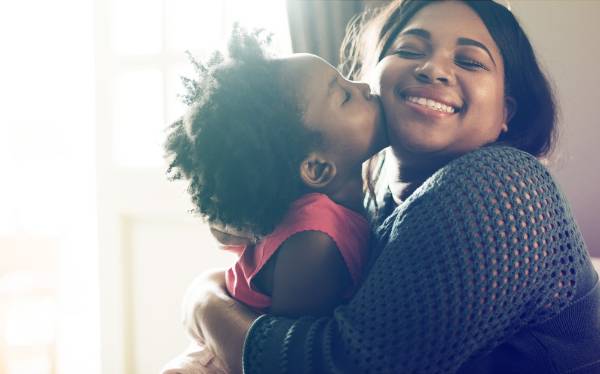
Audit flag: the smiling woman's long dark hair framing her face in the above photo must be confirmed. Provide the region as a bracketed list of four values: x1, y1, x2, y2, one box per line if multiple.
[340, 0, 558, 158]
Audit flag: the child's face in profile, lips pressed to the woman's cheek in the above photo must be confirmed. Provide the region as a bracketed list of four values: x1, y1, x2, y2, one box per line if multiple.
[286, 54, 387, 171]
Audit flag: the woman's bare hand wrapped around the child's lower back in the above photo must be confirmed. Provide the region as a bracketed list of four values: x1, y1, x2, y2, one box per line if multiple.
[183, 270, 258, 373]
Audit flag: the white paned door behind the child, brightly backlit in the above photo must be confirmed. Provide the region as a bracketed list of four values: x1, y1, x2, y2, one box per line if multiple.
[94, 0, 291, 374]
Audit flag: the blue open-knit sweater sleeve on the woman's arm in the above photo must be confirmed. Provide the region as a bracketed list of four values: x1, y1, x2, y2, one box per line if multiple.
[244, 147, 589, 374]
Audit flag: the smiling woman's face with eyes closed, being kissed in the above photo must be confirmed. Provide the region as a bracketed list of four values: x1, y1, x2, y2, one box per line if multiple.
[375, 1, 512, 163]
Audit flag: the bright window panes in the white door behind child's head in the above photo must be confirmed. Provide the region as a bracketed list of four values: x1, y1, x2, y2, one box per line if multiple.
[102, 0, 291, 167]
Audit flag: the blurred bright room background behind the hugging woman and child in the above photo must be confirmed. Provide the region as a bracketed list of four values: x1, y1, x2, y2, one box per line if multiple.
[0, 0, 600, 374]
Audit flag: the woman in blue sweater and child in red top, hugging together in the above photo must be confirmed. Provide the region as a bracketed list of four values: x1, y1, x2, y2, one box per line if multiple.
[165, 0, 600, 374]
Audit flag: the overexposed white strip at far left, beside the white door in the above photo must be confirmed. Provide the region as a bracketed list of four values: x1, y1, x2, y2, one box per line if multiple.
[0, 0, 100, 374]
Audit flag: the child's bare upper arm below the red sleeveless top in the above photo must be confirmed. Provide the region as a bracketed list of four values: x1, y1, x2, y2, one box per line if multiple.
[261, 231, 352, 316]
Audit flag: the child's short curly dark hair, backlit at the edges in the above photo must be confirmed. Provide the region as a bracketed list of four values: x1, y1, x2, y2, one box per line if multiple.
[165, 27, 319, 236]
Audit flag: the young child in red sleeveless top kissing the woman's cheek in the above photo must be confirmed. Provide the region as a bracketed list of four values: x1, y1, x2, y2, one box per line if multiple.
[165, 29, 387, 373]
